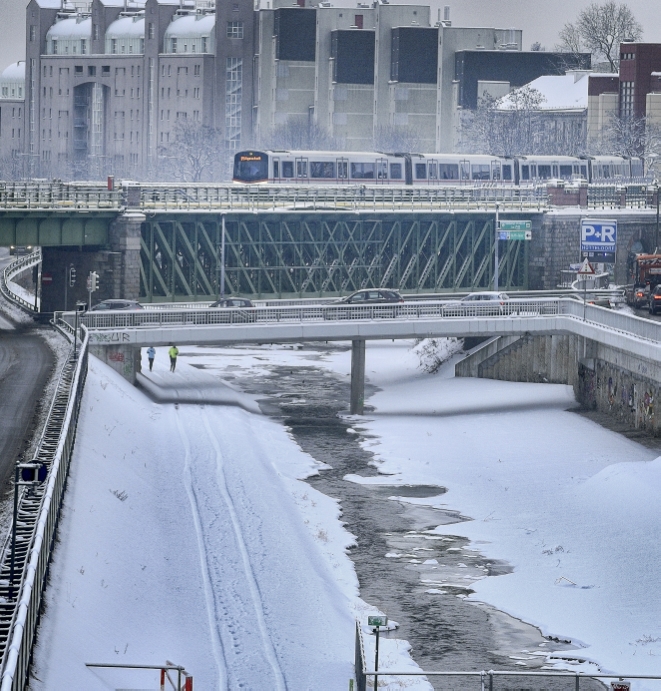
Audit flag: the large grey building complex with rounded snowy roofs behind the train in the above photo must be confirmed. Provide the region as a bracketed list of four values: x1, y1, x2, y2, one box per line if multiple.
[0, 0, 600, 177]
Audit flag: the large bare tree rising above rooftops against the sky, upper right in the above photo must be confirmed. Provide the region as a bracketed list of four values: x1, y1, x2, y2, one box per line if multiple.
[557, 0, 643, 72]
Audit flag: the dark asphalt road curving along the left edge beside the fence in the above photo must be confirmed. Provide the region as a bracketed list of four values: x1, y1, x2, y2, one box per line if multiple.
[0, 257, 54, 488]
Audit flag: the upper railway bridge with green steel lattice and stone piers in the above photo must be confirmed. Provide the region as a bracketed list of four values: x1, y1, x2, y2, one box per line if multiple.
[0, 183, 658, 312]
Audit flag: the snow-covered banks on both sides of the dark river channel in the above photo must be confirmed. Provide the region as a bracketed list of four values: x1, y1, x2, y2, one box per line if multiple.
[31, 342, 661, 691]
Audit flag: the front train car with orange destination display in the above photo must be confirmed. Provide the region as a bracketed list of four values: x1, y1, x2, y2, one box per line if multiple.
[233, 151, 406, 185]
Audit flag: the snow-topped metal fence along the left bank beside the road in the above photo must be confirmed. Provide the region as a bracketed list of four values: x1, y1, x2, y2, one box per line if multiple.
[0, 328, 88, 691]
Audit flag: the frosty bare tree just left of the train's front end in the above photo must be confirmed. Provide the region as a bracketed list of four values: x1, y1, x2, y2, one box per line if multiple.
[158, 118, 229, 182]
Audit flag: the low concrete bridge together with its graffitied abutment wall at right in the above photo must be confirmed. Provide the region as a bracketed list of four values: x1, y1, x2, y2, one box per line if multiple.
[77, 298, 661, 433]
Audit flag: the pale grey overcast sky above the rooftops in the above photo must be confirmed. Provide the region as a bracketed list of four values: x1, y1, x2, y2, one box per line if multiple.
[0, 0, 661, 69]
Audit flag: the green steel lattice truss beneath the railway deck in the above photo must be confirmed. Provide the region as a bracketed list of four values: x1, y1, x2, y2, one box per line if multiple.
[141, 211, 529, 302]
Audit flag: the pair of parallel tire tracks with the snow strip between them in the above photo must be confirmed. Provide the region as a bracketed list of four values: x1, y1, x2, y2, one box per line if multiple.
[177, 409, 287, 691]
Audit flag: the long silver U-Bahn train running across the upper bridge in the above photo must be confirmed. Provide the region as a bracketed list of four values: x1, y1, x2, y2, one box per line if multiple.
[233, 151, 645, 185]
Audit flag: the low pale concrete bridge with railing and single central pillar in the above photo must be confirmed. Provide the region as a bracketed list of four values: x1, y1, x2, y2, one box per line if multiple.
[64, 298, 661, 411]
